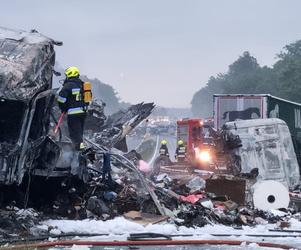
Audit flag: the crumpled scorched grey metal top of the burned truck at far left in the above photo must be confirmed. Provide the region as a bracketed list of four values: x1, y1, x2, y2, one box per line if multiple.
[0, 27, 59, 101]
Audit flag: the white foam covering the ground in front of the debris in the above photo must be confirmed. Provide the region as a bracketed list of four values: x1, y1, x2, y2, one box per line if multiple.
[38, 217, 301, 247]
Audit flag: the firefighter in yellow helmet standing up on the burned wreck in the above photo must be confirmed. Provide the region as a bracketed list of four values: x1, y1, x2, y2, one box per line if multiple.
[57, 66, 88, 151]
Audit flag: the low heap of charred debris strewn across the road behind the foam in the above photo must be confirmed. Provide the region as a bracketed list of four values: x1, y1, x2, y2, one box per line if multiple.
[0, 162, 301, 239]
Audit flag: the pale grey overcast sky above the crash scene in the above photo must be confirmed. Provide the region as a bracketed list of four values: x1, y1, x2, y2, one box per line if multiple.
[0, 0, 301, 107]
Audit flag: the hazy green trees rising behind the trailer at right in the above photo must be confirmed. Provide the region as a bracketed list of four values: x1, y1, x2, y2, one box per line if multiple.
[191, 40, 301, 117]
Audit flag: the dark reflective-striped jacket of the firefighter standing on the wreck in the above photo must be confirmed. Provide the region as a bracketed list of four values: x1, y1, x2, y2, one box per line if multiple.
[57, 77, 87, 115]
